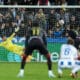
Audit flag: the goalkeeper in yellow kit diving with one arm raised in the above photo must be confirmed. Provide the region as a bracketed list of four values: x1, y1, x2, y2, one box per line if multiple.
[0, 27, 24, 55]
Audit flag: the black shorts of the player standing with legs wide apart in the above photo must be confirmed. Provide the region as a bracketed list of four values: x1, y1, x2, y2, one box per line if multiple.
[25, 38, 48, 55]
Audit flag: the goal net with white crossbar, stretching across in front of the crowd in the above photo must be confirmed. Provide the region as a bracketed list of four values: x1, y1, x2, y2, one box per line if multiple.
[0, 6, 80, 62]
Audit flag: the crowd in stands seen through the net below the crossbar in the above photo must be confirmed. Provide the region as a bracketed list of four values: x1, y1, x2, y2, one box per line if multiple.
[0, 8, 80, 37]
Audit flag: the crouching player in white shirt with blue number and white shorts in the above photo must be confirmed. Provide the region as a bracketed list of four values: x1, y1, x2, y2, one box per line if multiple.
[58, 38, 78, 77]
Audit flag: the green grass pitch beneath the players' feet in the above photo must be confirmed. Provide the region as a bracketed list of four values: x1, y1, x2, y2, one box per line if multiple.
[0, 63, 80, 80]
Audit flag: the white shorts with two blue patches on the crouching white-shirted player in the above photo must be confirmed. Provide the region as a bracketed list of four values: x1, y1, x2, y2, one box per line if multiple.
[58, 59, 75, 68]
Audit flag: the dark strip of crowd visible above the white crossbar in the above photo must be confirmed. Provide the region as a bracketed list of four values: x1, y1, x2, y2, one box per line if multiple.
[0, 0, 80, 5]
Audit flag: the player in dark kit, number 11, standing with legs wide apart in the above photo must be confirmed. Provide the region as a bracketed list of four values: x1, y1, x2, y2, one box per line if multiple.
[18, 21, 55, 77]
